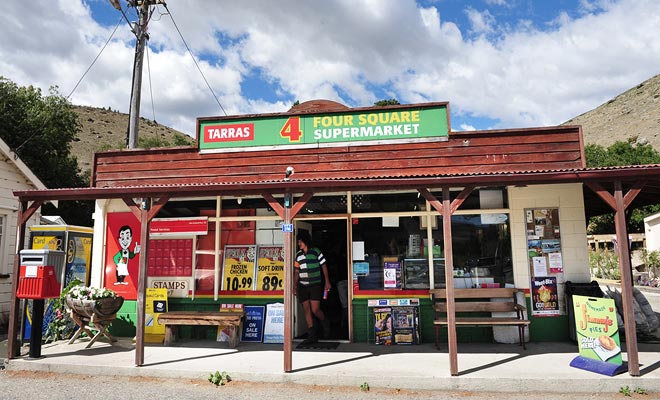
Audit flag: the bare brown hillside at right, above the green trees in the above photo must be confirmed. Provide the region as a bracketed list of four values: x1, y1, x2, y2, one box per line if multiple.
[562, 75, 660, 151]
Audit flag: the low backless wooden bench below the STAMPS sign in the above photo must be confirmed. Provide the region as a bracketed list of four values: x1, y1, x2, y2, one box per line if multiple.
[158, 310, 245, 348]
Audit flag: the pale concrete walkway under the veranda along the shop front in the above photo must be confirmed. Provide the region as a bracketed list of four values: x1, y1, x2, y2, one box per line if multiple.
[2, 339, 660, 393]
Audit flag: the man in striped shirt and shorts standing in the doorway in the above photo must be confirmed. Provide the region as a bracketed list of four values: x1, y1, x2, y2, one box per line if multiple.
[293, 231, 331, 344]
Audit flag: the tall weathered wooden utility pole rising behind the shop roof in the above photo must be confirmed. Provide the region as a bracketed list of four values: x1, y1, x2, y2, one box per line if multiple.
[126, 0, 156, 149]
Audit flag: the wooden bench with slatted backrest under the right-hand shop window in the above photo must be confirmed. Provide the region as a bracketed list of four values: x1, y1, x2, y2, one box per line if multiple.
[430, 288, 530, 349]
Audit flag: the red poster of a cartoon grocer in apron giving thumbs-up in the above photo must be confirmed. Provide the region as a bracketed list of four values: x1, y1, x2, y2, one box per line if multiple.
[104, 212, 141, 300]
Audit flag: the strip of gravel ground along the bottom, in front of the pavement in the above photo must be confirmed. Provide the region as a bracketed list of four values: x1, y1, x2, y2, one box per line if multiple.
[0, 370, 648, 400]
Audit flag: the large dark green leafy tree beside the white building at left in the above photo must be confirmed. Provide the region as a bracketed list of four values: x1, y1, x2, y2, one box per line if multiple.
[0, 76, 93, 225]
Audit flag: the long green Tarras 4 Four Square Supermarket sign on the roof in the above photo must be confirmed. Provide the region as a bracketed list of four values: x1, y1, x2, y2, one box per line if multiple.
[197, 103, 449, 151]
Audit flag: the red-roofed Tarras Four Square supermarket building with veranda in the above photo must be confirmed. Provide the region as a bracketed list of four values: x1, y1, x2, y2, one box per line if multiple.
[9, 101, 660, 376]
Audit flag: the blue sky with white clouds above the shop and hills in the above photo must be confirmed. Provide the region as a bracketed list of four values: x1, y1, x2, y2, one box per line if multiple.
[0, 0, 660, 137]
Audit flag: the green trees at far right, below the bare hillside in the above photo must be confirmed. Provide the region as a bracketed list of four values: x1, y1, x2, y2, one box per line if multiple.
[584, 141, 660, 234]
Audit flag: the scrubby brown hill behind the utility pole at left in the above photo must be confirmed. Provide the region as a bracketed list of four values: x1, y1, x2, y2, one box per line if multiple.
[71, 106, 195, 171]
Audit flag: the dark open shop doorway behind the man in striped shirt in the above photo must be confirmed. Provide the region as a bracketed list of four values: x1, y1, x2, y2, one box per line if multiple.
[295, 219, 348, 340]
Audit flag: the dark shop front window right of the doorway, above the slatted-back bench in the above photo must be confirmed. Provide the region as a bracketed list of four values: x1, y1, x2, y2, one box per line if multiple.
[352, 209, 513, 290]
